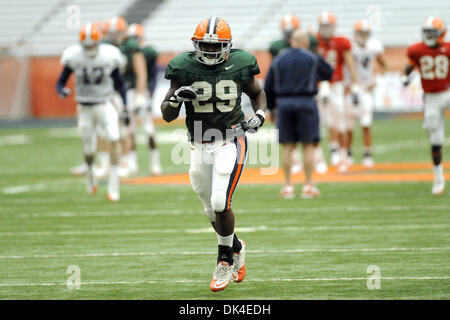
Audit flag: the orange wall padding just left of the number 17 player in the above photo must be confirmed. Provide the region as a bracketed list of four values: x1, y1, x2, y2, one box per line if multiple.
[30, 57, 76, 118]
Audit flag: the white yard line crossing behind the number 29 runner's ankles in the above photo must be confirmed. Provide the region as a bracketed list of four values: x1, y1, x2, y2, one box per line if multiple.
[0, 247, 450, 260]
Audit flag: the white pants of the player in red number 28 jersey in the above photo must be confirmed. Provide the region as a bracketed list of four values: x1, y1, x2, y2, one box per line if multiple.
[424, 90, 450, 146]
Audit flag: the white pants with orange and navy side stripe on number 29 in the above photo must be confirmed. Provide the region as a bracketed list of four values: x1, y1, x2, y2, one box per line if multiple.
[189, 136, 247, 221]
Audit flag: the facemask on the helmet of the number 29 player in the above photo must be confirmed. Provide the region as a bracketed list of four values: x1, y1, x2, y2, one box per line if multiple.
[192, 35, 232, 66]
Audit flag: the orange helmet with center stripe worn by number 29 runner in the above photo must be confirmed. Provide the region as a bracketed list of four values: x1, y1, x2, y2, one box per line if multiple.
[191, 17, 232, 65]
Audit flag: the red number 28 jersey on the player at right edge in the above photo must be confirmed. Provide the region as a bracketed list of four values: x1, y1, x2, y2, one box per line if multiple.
[407, 42, 450, 93]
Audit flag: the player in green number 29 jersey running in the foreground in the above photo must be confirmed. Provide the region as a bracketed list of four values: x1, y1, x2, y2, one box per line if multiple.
[161, 17, 266, 291]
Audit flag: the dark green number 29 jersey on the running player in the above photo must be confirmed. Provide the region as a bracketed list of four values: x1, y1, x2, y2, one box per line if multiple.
[165, 49, 260, 141]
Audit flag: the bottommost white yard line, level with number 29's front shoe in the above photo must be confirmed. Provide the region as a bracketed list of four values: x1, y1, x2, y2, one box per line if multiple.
[0, 276, 450, 287]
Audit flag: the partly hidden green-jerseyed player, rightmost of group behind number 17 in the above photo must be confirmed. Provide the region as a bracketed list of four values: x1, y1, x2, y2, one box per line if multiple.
[128, 23, 162, 175]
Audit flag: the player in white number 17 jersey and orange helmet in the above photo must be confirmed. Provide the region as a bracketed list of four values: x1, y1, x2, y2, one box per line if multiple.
[56, 23, 129, 202]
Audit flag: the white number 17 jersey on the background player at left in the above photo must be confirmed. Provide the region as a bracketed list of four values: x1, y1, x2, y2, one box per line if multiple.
[61, 43, 125, 103]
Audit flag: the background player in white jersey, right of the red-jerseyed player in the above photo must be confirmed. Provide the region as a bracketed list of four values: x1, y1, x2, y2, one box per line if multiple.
[345, 20, 387, 168]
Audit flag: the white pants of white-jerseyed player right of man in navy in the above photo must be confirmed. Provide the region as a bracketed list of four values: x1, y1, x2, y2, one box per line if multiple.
[345, 89, 374, 130]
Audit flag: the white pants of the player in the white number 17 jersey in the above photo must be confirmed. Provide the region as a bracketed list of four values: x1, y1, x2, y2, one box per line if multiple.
[77, 102, 120, 155]
